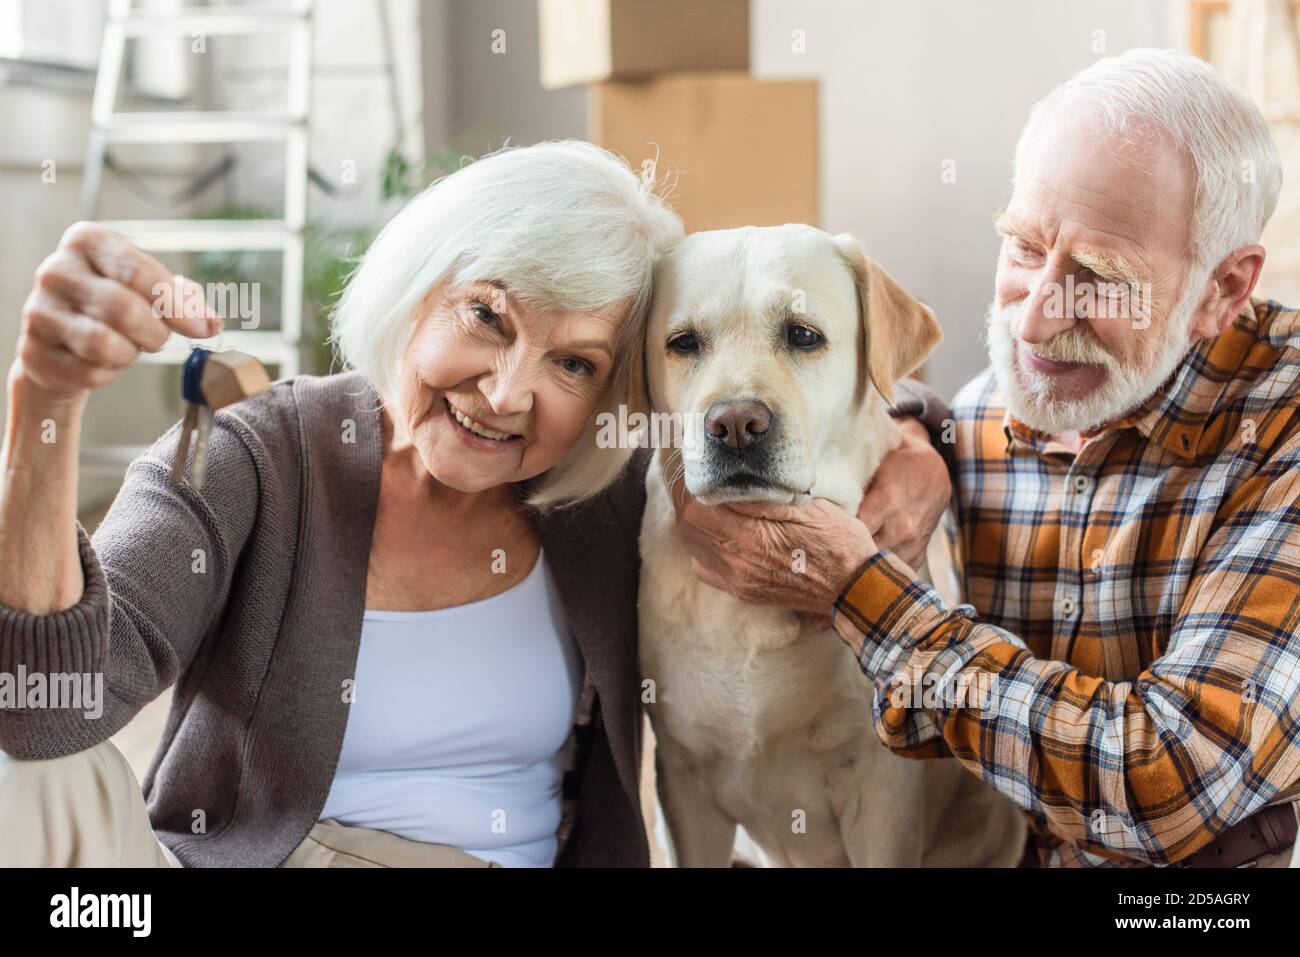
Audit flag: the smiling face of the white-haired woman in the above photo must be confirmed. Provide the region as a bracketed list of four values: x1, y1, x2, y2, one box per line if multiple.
[398, 281, 627, 492]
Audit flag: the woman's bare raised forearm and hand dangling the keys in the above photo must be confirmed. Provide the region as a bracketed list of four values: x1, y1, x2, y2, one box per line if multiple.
[0, 222, 221, 615]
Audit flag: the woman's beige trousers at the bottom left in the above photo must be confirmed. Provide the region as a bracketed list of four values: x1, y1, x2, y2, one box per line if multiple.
[0, 741, 501, 867]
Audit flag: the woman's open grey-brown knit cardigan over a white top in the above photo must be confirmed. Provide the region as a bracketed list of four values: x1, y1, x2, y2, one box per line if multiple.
[0, 373, 649, 867]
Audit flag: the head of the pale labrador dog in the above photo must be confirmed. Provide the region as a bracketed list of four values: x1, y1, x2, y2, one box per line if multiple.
[646, 224, 940, 505]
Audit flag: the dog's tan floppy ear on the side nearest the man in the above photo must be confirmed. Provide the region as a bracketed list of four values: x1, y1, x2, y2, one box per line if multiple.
[835, 233, 944, 403]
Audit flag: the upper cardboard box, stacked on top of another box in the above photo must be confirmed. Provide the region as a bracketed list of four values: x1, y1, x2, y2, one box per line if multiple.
[537, 0, 749, 90]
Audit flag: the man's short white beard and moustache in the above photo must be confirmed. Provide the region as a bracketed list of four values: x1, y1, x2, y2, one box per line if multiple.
[985, 282, 1204, 434]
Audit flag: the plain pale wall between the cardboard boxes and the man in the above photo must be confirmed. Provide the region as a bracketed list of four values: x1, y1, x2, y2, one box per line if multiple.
[751, 0, 1184, 397]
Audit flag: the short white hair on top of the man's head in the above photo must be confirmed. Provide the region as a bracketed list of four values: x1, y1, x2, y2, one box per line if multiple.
[1015, 49, 1282, 273]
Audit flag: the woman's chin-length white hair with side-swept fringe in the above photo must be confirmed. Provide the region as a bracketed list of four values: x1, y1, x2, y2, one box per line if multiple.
[330, 140, 683, 508]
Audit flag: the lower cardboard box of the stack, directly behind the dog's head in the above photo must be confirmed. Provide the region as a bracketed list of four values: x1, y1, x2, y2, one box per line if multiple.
[588, 73, 820, 231]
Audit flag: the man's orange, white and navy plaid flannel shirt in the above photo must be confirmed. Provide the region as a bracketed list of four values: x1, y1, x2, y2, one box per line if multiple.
[835, 300, 1300, 866]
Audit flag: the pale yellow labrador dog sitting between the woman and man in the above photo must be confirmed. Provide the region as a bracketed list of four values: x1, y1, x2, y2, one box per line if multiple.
[640, 225, 1024, 866]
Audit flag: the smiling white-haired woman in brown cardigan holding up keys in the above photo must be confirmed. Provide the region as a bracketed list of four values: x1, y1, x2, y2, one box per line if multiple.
[0, 142, 946, 866]
